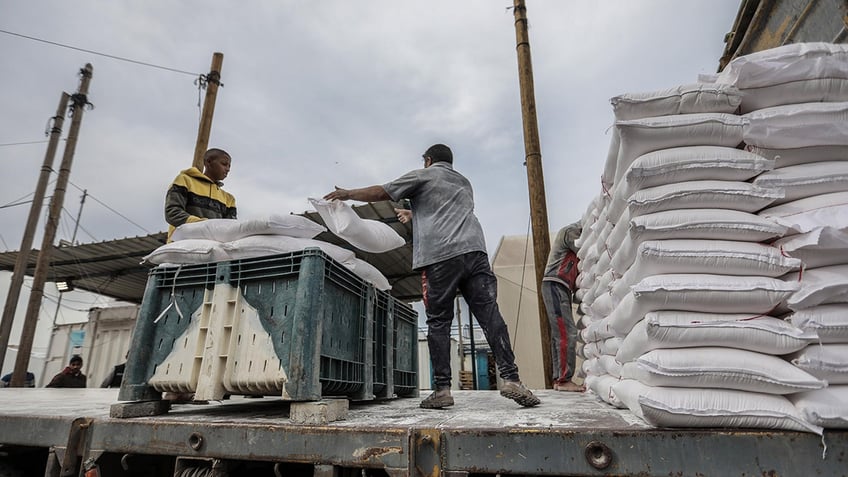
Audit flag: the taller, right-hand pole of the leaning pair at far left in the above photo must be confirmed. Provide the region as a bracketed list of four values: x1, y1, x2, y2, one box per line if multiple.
[10, 63, 94, 387]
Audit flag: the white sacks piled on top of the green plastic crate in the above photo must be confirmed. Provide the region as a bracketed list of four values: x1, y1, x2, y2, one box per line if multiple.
[143, 213, 403, 290]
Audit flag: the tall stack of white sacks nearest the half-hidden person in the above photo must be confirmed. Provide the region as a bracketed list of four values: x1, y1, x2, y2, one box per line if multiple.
[578, 63, 826, 433]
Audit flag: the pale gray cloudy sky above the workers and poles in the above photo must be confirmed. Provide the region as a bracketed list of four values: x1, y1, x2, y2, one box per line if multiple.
[0, 0, 740, 280]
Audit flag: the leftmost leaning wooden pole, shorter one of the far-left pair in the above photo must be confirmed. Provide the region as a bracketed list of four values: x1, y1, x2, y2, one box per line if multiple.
[0, 92, 70, 370]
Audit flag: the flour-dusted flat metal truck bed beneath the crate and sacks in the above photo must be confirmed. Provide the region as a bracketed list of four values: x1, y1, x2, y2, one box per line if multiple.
[0, 389, 848, 476]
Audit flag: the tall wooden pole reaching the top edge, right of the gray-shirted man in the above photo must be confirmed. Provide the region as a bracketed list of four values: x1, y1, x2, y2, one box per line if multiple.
[513, 0, 552, 388]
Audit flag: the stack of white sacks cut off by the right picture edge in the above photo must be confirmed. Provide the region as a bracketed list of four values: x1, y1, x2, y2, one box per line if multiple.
[717, 43, 848, 428]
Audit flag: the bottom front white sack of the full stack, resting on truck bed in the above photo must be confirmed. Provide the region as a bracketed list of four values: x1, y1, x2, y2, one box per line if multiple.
[612, 379, 822, 435]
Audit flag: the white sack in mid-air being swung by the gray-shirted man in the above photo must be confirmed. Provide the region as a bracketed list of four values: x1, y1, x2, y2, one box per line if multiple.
[309, 199, 406, 253]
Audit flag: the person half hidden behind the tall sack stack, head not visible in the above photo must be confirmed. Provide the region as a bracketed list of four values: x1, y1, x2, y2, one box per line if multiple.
[542, 222, 586, 392]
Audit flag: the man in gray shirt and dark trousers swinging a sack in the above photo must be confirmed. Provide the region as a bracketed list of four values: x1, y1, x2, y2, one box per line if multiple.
[324, 144, 540, 409]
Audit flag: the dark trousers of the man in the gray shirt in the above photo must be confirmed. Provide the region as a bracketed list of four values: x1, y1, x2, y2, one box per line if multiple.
[421, 252, 519, 389]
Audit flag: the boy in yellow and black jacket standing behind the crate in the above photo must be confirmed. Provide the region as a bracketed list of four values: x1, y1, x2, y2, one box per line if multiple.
[165, 148, 236, 242]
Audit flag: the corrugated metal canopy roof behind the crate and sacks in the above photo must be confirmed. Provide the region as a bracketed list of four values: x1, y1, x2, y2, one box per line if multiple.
[0, 201, 421, 303]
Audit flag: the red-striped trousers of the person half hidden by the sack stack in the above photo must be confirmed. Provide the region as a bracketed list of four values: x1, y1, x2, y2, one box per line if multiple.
[542, 281, 577, 384]
